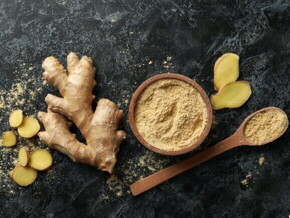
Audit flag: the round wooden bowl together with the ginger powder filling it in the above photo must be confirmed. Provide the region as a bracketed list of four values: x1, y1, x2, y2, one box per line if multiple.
[129, 73, 212, 155]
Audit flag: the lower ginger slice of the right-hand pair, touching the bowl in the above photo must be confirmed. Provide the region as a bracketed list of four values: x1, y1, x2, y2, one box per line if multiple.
[211, 81, 252, 110]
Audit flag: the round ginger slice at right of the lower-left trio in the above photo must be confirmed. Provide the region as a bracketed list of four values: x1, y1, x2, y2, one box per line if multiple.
[28, 149, 53, 170]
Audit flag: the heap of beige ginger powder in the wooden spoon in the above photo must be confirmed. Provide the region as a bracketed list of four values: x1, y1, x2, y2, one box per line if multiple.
[244, 109, 288, 144]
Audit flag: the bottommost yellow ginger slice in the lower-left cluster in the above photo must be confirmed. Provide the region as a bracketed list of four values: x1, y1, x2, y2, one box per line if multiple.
[9, 165, 37, 186]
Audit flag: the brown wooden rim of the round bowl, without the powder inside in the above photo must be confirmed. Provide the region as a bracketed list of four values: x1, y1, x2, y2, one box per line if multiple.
[129, 73, 212, 155]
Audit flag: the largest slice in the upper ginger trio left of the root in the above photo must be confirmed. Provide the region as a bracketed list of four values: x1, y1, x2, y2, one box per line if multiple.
[17, 117, 40, 138]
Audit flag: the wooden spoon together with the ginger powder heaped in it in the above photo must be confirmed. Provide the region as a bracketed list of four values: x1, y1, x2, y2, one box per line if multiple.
[130, 107, 289, 195]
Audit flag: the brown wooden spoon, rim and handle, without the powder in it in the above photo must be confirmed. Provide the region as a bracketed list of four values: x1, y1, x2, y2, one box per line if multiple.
[130, 107, 289, 196]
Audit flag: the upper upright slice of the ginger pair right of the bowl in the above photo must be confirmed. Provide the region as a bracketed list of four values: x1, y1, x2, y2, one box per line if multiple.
[213, 53, 239, 91]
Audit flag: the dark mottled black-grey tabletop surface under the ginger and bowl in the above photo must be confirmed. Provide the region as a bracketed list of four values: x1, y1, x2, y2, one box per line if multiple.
[0, 0, 290, 218]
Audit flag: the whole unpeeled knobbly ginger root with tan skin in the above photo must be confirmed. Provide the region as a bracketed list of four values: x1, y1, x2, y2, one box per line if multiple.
[38, 53, 126, 173]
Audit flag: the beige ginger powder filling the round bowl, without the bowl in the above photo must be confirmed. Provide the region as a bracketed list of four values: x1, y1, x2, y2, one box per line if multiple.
[135, 79, 207, 150]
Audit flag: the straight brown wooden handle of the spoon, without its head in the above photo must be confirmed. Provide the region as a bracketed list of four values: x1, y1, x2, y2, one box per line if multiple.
[130, 134, 242, 196]
